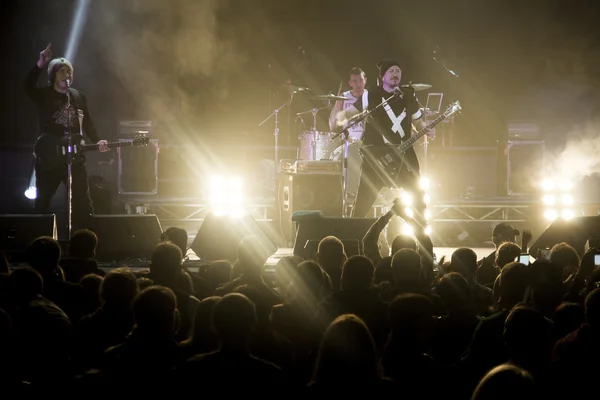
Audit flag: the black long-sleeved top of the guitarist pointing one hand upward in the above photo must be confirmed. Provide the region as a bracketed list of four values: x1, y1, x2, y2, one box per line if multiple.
[25, 65, 100, 143]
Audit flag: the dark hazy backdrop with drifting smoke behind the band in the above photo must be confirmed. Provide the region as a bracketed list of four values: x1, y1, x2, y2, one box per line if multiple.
[0, 0, 600, 212]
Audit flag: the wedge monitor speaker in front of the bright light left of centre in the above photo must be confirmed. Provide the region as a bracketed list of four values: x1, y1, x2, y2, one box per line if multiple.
[191, 213, 277, 262]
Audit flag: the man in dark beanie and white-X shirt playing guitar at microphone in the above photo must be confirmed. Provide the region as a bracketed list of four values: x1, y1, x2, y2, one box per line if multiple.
[337, 60, 434, 232]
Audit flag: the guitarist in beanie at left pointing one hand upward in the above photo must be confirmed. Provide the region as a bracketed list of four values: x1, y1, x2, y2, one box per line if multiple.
[25, 44, 109, 228]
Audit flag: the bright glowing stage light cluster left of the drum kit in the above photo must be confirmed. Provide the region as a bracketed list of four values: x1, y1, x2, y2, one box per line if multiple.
[210, 176, 245, 217]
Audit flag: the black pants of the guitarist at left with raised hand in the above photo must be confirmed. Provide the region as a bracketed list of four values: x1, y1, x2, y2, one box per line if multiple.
[33, 158, 94, 229]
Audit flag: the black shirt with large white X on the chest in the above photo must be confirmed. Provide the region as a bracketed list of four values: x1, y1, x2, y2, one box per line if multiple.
[354, 86, 423, 145]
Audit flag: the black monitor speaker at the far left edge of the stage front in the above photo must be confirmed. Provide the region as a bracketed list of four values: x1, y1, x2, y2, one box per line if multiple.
[0, 214, 58, 262]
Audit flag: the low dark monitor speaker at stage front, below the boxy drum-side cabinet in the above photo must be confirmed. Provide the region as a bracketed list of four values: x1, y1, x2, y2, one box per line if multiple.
[294, 215, 377, 258]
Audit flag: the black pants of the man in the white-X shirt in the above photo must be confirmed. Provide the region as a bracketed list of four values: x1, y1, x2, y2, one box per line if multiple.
[352, 148, 427, 232]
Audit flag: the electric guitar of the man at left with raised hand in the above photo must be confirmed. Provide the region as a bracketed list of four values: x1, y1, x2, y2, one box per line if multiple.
[33, 133, 150, 169]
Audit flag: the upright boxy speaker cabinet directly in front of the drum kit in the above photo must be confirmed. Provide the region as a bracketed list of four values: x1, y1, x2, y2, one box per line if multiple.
[278, 174, 343, 247]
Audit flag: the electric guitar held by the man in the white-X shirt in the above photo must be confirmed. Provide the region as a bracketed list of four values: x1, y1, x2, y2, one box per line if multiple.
[359, 101, 462, 187]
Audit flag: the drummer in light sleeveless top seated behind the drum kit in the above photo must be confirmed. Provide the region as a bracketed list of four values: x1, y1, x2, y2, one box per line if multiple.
[329, 67, 368, 141]
